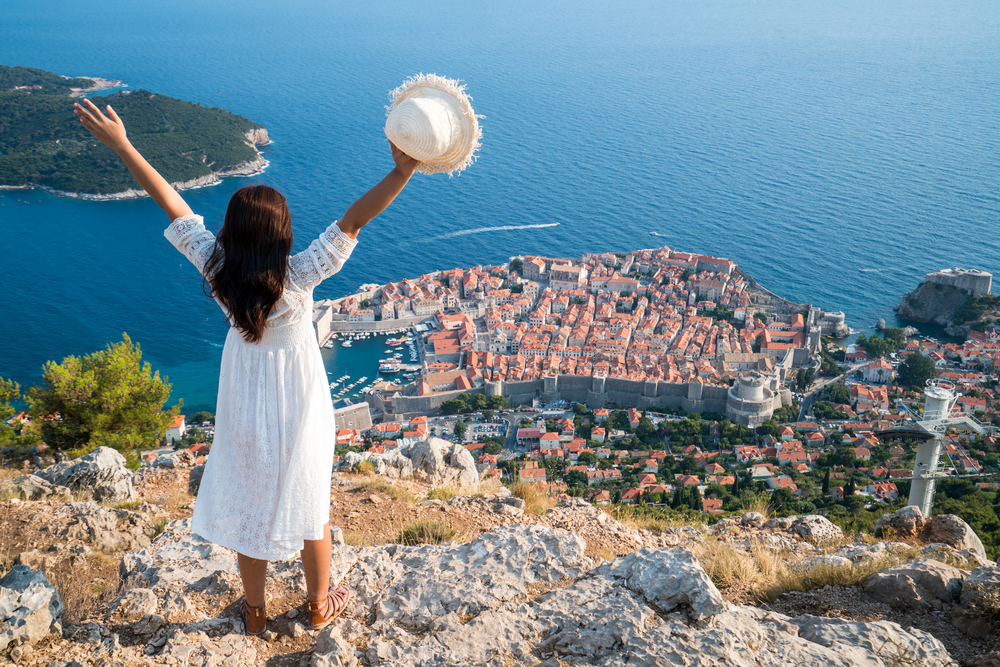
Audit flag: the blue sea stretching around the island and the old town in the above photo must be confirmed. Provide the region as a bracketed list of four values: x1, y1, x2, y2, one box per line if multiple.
[0, 0, 1000, 411]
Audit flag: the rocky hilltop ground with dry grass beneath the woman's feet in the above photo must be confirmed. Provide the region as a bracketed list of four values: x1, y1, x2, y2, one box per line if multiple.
[0, 451, 1000, 667]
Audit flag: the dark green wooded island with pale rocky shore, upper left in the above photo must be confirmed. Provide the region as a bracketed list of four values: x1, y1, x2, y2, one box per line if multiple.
[0, 65, 269, 200]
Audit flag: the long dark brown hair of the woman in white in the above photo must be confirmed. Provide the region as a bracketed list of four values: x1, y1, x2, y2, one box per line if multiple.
[205, 185, 292, 343]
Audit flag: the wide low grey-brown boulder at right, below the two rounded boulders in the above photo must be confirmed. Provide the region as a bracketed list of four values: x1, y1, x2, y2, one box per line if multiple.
[861, 558, 969, 612]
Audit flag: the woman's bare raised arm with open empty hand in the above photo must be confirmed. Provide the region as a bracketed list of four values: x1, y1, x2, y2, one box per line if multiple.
[73, 99, 191, 222]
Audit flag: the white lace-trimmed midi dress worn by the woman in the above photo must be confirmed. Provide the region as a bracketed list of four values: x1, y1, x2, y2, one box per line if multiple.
[164, 215, 357, 560]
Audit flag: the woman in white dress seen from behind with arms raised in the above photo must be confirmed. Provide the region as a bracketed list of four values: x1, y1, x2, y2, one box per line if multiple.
[74, 100, 418, 635]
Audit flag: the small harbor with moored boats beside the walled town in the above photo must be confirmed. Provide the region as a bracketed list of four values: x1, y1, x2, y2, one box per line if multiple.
[320, 329, 421, 403]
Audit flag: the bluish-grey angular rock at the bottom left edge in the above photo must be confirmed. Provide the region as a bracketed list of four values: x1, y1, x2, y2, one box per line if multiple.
[0, 565, 63, 651]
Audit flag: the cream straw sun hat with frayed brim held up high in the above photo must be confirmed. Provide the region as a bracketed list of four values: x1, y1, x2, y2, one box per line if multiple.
[385, 74, 483, 176]
